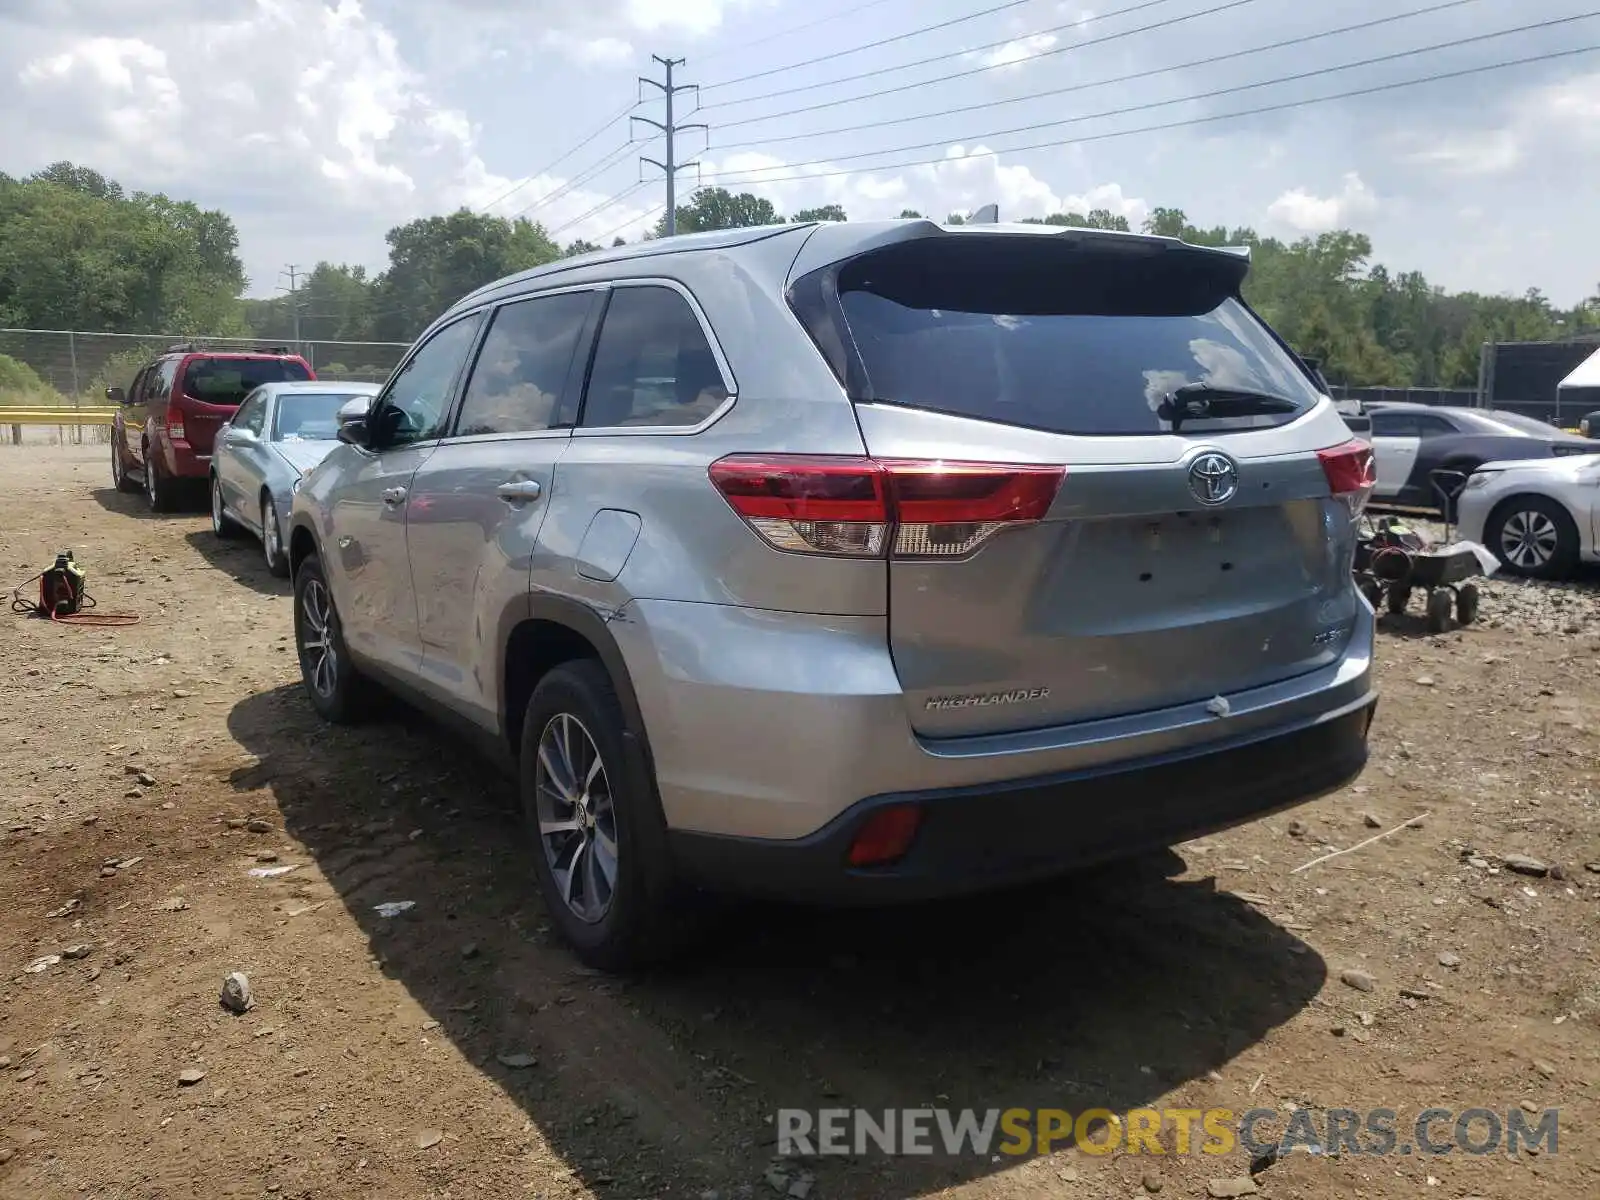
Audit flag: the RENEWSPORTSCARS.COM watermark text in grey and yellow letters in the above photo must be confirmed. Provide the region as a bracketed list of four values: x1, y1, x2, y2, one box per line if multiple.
[778, 1107, 1560, 1158]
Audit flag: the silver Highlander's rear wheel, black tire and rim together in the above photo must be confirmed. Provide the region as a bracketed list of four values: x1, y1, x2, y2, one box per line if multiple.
[518, 659, 693, 971]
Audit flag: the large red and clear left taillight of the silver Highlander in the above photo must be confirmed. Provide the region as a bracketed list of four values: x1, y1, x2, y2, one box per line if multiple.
[710, 454, 1066, 558]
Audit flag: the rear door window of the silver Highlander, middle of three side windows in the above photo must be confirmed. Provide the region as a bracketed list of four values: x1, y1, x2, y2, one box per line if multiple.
[456, 291, 594, 437]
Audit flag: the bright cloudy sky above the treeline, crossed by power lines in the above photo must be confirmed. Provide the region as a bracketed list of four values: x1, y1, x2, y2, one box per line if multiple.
[0, 0, 1600, 306]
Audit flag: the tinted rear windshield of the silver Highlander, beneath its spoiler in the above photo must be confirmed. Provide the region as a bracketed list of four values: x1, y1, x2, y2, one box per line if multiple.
[812, 234, 1318, 435]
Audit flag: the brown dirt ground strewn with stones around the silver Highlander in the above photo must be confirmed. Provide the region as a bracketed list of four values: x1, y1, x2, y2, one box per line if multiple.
[0, 446, 1600, 1200]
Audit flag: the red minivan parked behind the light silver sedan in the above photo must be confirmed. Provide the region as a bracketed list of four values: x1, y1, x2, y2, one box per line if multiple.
[106, 346, 317, 512]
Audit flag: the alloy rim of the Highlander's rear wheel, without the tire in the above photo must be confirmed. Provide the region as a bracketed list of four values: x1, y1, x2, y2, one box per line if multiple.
[533, 712, 618, 925]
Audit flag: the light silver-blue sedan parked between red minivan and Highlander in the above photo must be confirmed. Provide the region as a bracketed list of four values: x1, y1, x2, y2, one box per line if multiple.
[211, 381, 379, 578]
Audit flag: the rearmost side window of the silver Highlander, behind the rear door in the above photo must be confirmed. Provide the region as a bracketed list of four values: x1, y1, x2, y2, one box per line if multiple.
[581, 285, 728, 429]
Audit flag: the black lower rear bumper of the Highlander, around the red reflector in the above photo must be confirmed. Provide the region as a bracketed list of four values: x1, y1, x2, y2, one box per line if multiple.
[670, 693, 1378, 904]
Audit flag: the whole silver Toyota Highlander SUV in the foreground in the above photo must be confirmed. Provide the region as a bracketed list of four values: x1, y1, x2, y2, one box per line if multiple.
[290, 221, 1376, 968]
